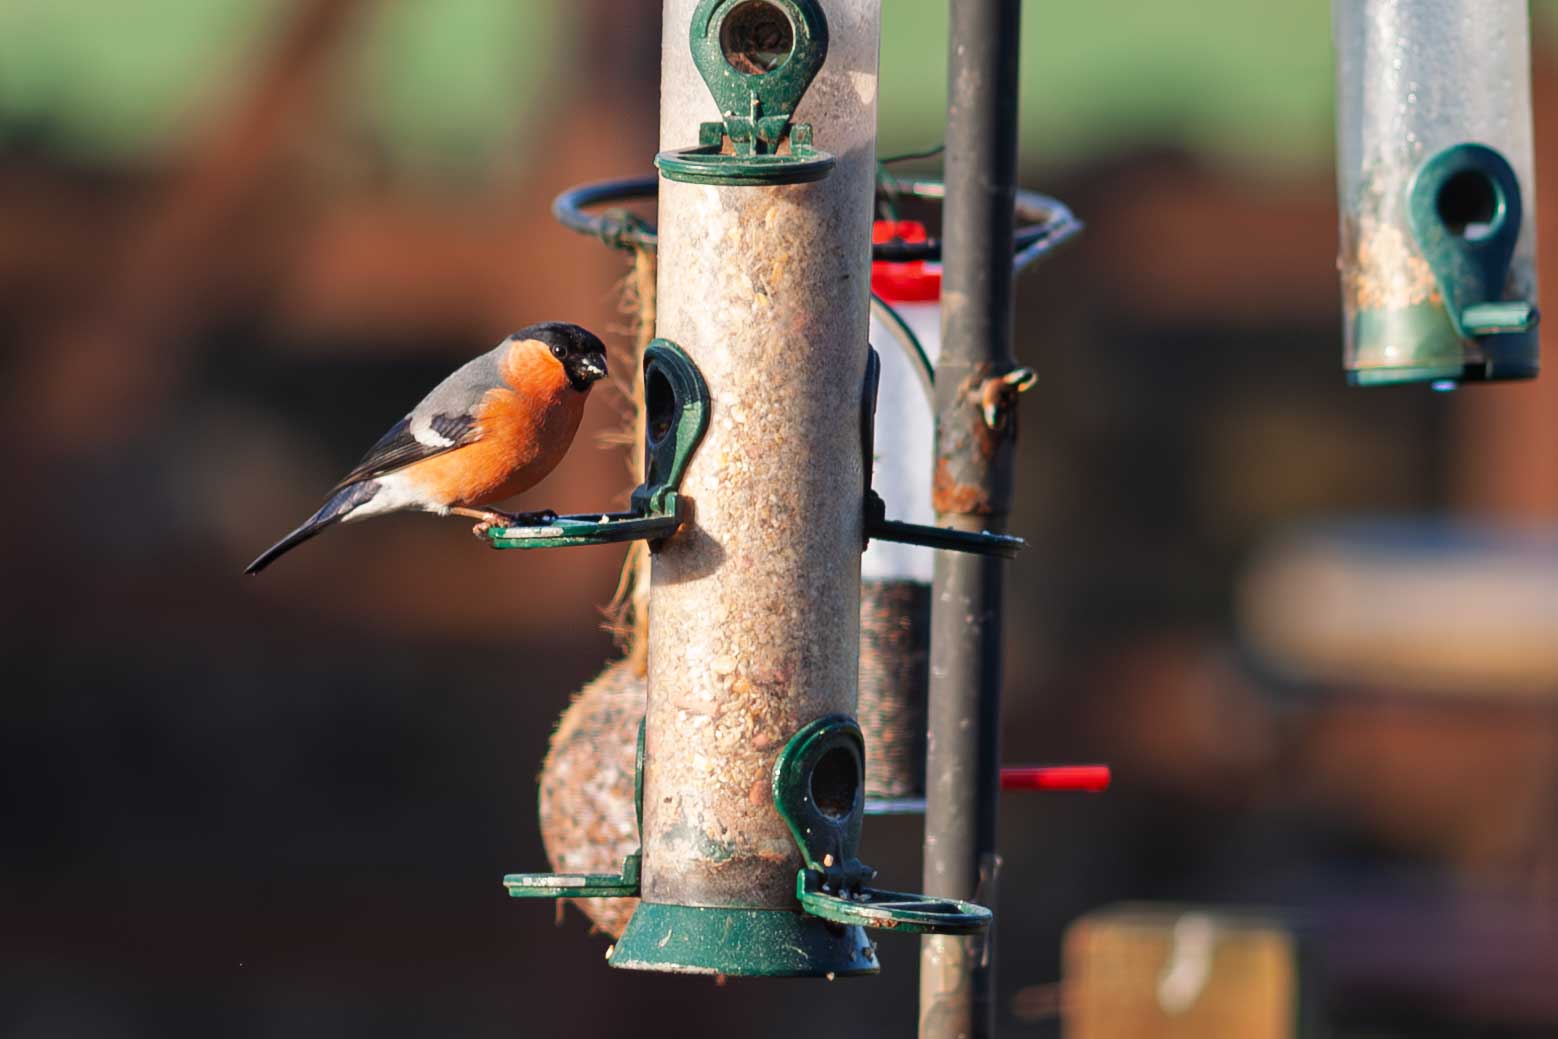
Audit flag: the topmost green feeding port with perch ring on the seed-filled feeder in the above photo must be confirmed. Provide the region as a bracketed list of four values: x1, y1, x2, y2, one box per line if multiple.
[654, 0, 834, 185]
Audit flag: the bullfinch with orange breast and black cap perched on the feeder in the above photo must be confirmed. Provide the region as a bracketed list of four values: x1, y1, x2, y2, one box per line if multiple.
[245, 321, 606, 573]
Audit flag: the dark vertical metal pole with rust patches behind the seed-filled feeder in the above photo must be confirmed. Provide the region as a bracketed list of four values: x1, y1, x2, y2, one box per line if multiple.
[919, 0, 1019, 1039]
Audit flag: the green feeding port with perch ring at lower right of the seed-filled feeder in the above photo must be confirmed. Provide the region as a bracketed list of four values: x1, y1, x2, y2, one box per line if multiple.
[774, 715, 991, 935]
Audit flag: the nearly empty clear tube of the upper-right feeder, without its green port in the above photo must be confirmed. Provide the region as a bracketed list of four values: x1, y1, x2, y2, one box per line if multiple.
[1332, 0, 1538, 385]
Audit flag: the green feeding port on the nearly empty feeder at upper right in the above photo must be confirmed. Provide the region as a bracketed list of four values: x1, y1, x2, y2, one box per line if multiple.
[1407, 143, 1538, 340]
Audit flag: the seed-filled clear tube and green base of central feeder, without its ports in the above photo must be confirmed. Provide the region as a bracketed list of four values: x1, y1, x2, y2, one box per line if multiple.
[612, 0, 880, 974]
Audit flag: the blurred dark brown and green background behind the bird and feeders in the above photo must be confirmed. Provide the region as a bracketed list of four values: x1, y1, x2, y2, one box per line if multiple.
[9, 0, 1558, 1039]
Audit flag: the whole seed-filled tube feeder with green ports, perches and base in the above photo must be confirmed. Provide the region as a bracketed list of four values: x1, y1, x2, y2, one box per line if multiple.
[494, 0, 997, 977]
